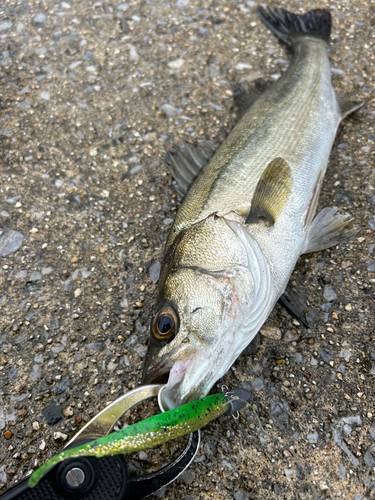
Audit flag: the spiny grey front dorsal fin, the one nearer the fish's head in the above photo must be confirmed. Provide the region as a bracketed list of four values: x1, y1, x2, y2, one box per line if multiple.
[165, 133, 226, 195]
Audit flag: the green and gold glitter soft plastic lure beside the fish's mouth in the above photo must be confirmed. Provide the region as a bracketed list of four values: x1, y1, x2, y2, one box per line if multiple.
[29, 392, 245, 488]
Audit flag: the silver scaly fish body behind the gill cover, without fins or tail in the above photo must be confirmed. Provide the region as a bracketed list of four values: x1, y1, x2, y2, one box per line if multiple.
[172, 38, 341, 298]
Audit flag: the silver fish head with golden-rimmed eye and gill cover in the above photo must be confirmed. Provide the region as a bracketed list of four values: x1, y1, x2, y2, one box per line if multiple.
[143, 218, 270, 408]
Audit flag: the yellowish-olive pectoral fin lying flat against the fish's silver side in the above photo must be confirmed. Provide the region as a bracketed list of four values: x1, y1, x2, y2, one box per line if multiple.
[245, 158, 292, 226]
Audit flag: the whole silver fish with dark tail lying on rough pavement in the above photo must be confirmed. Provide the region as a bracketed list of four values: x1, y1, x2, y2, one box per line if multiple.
[143, 6, 363, 408]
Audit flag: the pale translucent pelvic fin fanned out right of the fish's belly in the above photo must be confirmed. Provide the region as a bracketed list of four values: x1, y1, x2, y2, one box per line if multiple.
[302, 207, 358, 254]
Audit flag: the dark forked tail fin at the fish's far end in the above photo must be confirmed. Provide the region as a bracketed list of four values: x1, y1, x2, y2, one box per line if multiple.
[257, 6, 332, 45]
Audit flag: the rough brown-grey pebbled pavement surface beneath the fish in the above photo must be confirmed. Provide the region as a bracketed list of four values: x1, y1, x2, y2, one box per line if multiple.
[0, 0, 375, 500]
